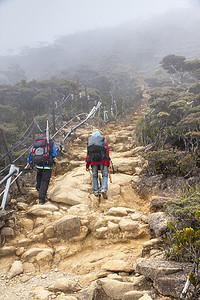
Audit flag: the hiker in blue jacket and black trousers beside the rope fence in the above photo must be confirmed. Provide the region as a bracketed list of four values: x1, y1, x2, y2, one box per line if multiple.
[26, 132, 57, 204]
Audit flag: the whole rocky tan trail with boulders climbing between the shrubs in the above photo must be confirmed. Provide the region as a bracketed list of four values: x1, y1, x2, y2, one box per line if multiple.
[0, 106, 186, 300]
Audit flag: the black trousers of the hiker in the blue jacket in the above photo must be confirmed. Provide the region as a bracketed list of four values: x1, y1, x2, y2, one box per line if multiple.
[36, 168, 52, 203]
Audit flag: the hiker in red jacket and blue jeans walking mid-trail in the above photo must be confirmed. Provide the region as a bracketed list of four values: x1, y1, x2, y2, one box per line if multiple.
[85, 131, 110, 199]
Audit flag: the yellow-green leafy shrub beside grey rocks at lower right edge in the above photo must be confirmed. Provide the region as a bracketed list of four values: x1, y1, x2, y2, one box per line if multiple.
[165, 185, 200, 261]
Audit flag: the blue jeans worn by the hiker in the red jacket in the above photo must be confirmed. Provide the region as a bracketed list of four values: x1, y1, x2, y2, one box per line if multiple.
[92, 165, 108, 193]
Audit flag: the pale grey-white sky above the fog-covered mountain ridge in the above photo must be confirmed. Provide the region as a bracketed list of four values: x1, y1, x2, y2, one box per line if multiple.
[0, 0, 195, 55]
